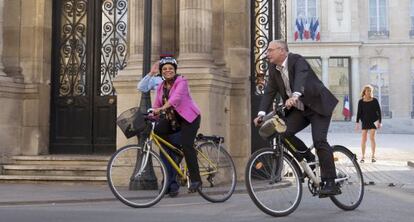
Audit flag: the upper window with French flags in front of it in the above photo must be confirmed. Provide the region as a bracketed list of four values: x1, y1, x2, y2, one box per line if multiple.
[292, 0, 320, 41]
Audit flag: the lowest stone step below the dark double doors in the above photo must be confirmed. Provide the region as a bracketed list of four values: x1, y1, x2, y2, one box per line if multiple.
[0, 175, 106, 184]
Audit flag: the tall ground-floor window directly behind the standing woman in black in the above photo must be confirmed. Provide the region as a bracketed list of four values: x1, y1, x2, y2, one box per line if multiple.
[369, 58, 392, 118]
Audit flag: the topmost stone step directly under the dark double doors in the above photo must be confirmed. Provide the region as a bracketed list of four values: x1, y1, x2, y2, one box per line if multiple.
[11, 155, 110, 166]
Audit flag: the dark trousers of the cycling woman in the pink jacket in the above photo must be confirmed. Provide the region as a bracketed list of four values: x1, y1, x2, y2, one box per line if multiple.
[154, 116, 201, 182]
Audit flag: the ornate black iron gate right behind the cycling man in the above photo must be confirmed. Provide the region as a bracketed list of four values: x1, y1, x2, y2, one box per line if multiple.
[251, 0, 286, 152]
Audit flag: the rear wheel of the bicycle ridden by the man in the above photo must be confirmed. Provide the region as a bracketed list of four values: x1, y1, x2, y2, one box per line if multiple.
[330, 145, 364, 210]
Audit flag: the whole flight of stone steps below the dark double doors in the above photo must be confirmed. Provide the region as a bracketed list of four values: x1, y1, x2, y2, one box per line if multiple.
[0, 155, 110, 184]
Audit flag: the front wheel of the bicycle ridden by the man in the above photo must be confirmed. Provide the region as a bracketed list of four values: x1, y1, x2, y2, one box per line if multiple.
[245, 148, 302, 217]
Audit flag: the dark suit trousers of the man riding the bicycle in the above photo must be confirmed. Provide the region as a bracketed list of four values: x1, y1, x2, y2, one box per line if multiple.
[283, 107, 336, 180]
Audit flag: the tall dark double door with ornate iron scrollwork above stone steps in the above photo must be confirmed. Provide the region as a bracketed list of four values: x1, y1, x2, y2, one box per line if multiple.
[50, 0, 128, 153]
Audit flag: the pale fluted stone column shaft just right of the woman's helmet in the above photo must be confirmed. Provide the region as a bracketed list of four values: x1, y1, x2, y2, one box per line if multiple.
[179, 0, 213, 73]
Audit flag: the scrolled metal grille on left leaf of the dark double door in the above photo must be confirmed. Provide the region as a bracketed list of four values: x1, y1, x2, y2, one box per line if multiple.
[59, 0, 87, 96]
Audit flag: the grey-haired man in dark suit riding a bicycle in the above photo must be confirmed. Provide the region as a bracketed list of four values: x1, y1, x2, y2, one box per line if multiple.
[254, 40, 341, 197]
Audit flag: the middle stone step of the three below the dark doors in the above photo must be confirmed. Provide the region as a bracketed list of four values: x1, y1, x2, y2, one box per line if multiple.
[2, 164, 106, 176]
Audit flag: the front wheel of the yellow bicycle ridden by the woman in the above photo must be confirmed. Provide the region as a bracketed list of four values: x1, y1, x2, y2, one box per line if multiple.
[106, 145, 167, 208]
